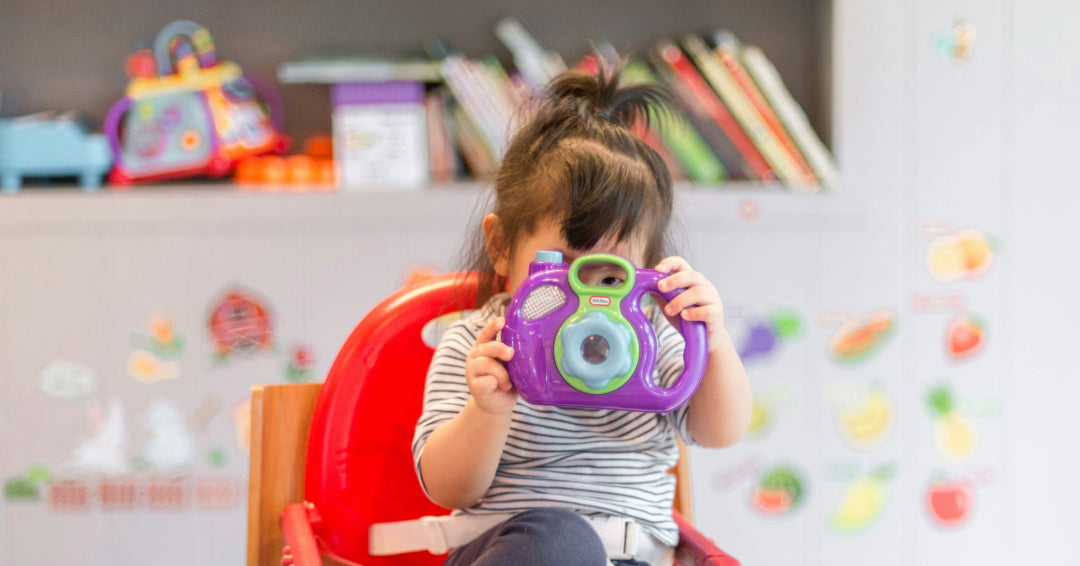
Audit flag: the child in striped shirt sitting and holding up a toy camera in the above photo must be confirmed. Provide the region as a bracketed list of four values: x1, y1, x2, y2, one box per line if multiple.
[413, 59, 751, 566]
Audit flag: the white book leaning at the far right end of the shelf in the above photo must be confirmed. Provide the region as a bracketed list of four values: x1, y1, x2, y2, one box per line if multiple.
[742, 45, 837, 189]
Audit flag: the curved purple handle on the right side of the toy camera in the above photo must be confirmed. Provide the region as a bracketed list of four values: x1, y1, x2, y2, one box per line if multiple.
[626, 269, 708, 410]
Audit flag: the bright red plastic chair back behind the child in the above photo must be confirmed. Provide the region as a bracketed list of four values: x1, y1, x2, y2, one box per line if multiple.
[305, 273, 476, 566]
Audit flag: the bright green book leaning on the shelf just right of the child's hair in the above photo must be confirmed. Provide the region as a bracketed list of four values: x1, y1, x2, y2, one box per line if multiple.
[622, 60, 725, 185]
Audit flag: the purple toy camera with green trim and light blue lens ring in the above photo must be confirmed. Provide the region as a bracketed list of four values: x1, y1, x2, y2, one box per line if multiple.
[502, 252, 707, 413]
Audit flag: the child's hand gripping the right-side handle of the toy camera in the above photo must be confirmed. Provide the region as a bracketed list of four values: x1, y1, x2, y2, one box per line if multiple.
[656, 256, 727, 353]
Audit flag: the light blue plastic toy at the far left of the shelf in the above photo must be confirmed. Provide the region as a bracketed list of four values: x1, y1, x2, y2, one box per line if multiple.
[0, 112, 112, 194]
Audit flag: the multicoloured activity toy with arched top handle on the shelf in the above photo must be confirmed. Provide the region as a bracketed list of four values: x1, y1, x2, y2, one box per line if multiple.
[105, 21, 288, 185]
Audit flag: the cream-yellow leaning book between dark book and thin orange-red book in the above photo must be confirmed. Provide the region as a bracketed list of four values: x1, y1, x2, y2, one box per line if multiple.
[683, 35, 807, 186]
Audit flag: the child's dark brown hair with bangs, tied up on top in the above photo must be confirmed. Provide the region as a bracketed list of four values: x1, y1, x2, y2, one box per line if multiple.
[468, 57, 672, 304]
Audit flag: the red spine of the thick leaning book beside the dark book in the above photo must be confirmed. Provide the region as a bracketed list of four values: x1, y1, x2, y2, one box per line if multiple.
[659, 42, 777, 180]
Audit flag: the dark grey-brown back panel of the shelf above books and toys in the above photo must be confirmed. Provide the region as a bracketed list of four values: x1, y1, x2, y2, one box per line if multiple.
[0, 0, 833, 186]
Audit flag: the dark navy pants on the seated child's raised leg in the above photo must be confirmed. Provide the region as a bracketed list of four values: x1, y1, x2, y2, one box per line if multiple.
[444, 508, 649, 566]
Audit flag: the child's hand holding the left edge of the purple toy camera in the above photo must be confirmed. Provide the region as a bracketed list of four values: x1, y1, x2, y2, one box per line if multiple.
[465, 316, 517, 415]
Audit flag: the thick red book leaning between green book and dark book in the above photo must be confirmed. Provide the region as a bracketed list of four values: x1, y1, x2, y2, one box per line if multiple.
[649, 41, 777, 180]
